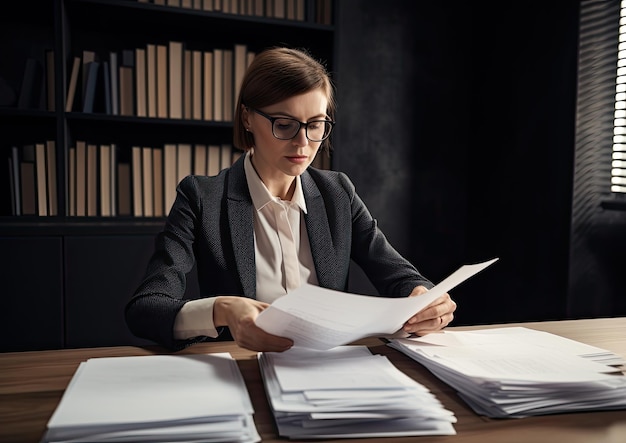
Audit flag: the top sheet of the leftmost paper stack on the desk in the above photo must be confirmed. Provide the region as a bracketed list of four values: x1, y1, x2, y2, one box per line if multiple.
[49, 354, 251, 427]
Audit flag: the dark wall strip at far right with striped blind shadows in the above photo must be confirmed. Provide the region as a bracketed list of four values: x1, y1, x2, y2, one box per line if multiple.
[568, 0, 626, 317]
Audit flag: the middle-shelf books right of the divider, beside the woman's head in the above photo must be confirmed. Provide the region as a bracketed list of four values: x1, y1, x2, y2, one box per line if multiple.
[65, 41, 255, 121]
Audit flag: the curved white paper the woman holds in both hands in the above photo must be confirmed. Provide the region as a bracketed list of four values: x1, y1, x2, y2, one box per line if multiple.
[256, 258, 498, 350]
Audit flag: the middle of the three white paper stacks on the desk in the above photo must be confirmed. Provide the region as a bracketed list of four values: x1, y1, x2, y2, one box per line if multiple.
[259, 346, 456, 439]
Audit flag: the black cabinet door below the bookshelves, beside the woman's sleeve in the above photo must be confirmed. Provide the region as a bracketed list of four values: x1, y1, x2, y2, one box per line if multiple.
[64, 235, 198, 348]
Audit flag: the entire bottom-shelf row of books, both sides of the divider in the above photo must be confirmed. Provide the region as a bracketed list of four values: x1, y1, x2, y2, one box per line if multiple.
[9, 140, 241, 217]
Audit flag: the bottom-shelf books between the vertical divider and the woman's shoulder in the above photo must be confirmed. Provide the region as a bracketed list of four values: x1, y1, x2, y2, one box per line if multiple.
[68, 141, 241, 217]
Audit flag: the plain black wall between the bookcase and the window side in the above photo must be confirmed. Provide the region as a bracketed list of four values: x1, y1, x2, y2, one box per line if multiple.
[333, 0, 592, 324]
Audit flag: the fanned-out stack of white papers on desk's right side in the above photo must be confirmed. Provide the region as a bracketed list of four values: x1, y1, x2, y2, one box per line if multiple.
[389, 327, 626, 418]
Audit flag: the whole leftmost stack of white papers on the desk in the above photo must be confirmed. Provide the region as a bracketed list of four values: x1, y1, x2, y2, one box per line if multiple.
[44, 353, 260, 443]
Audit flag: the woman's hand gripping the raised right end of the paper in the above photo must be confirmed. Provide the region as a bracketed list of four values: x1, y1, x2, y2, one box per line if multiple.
[402, 286, 456, 335]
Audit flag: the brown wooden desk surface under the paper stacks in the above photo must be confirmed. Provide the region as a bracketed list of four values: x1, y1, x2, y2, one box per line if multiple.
[0, 317, 626, 443]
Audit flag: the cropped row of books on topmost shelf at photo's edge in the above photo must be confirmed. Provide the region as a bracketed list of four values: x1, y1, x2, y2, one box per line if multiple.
[138, 0, 332, 25]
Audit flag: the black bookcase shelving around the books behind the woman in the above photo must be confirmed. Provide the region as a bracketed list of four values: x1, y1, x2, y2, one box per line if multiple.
[0, 0, 335, 224]
